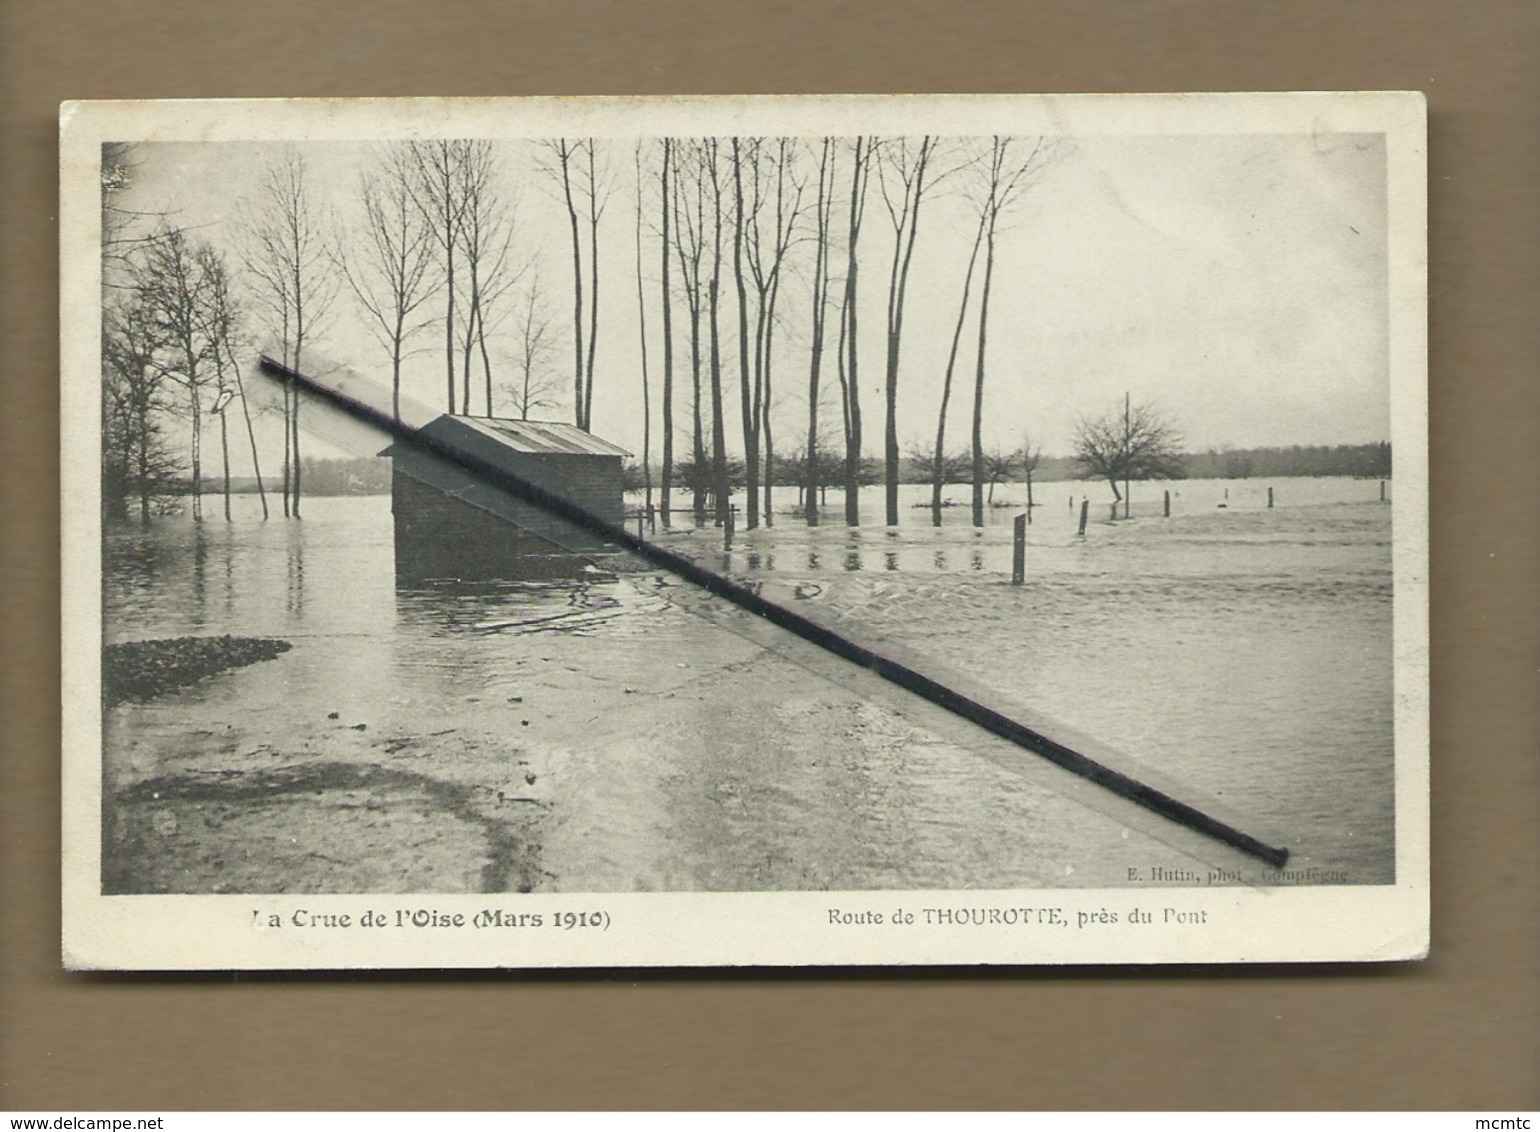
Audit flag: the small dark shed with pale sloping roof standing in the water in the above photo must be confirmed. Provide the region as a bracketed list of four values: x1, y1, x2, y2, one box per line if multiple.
[391, 413, 628, 582]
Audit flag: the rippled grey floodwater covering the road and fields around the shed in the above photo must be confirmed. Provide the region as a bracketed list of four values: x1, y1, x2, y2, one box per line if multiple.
[103, 479, 1394, 892]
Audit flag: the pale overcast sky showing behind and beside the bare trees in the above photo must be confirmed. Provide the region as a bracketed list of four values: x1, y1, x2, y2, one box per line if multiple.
[113, 134, 1389, 461]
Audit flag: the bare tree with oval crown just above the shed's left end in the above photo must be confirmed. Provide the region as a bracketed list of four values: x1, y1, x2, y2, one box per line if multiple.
[337, 145, 436, 420]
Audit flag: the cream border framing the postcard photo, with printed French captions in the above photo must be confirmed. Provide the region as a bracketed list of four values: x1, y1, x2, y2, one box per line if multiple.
[60, 92, 1429, 970]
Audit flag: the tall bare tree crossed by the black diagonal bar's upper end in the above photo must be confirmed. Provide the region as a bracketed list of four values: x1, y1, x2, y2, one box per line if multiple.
[242, 146, 339, 519]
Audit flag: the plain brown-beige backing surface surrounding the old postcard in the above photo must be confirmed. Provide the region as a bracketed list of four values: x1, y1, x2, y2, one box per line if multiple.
[0, 0, 1540, 1112]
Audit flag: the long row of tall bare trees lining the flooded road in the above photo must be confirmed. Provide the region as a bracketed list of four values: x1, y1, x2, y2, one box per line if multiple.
[102, 137, 1056, 527]
